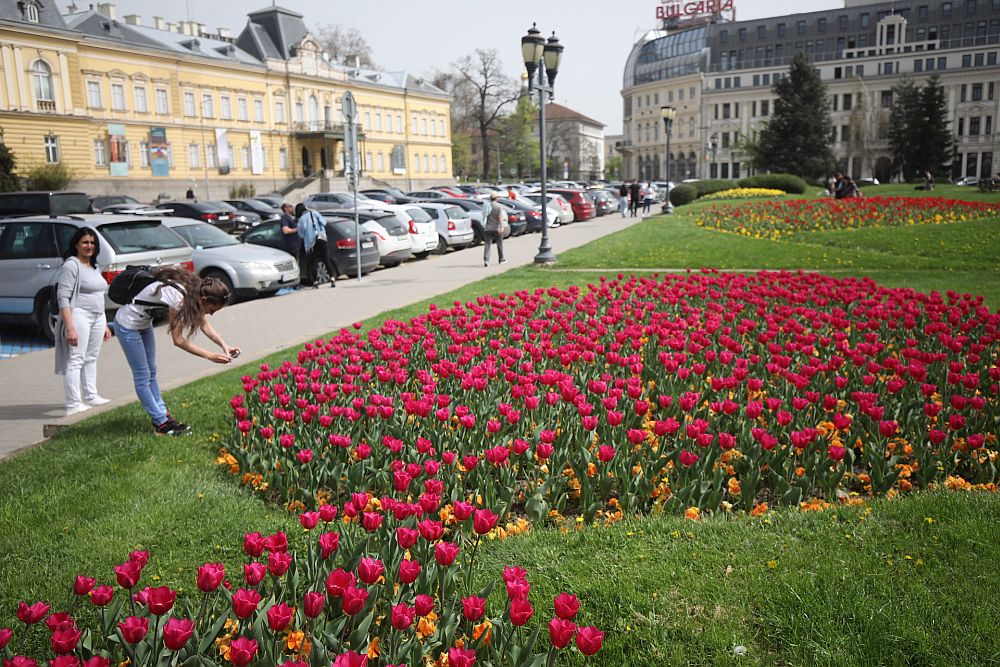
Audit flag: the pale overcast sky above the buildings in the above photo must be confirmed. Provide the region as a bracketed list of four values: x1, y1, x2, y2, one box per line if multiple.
[97, 0, 844, 134]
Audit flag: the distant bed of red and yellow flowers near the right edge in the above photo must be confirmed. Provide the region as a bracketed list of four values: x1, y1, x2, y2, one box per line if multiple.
[695, 197, 1000, 240]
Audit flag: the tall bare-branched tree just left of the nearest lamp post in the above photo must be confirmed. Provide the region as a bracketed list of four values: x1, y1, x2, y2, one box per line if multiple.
[451, 49, 520, 180]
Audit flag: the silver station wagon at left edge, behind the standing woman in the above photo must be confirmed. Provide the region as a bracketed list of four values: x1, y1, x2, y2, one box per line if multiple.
[0, 215, 194, 342]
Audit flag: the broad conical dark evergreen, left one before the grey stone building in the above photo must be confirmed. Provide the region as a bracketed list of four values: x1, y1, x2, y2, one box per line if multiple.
[748, 53, 834, 180]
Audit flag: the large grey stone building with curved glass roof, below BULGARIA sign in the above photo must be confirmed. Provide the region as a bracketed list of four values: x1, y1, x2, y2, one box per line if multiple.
[619, 0, 1000, 182]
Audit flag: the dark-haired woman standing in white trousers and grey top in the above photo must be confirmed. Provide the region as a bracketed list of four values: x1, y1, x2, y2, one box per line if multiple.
[55, 227, 111, 417]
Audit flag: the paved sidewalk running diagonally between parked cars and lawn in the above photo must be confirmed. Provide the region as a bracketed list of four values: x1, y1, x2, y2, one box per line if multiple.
[0, 213, 642, 460]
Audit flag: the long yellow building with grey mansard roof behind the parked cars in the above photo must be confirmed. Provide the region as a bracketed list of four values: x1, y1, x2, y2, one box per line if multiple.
[0, 0, 453, 201]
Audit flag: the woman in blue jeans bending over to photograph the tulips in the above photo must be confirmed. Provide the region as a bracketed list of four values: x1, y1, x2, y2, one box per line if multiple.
[115, 266, 240, 435]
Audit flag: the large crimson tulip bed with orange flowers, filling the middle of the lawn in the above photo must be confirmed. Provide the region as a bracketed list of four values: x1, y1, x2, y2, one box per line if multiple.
[220, 272, 1000, 524]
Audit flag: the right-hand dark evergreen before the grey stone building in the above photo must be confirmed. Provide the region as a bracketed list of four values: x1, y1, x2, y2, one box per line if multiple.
[889, 74, 956, 180]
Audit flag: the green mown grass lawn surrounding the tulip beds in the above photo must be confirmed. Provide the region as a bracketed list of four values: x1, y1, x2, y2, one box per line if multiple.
[0, 188, 1000, 665]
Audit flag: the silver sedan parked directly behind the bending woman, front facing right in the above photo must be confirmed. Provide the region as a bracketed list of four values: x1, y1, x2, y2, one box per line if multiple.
[163, 218, 299, 298]
